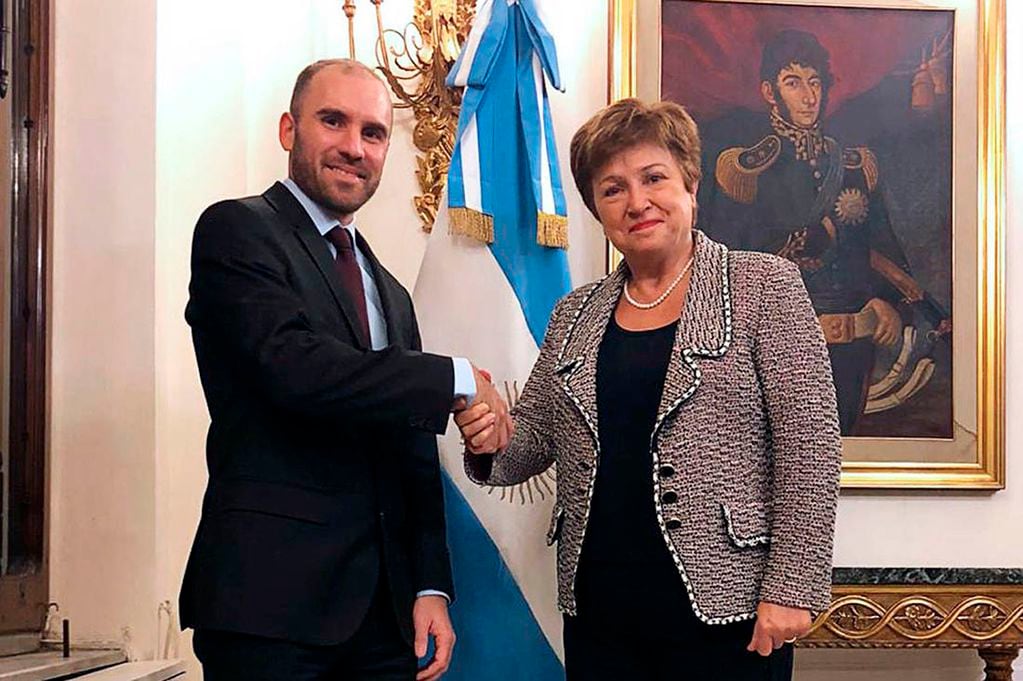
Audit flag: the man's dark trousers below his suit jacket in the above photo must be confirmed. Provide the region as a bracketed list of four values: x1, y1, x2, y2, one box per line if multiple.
[192, 579, 416, 681]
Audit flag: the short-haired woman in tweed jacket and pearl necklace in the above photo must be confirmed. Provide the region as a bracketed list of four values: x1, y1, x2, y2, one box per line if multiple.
[456, 99, 841, 681]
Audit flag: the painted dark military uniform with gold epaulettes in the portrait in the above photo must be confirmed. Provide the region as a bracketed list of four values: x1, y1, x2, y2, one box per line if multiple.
[701, 114, 923, 434]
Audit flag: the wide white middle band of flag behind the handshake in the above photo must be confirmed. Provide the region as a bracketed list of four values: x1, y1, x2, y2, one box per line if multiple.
[413, 197, 565, 660]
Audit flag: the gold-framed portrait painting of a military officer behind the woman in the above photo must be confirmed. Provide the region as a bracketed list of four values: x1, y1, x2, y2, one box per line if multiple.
[609, 0, 1005, 489]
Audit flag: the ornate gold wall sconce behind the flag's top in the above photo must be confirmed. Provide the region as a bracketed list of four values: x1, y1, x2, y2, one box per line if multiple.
[344, 0, 476, 232]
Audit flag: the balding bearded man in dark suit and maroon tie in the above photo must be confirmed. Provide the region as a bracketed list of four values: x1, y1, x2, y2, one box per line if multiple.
[181, 59, 506, 681]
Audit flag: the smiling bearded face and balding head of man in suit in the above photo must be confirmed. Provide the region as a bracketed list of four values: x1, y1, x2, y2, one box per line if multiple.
[279, 66, 391, 223]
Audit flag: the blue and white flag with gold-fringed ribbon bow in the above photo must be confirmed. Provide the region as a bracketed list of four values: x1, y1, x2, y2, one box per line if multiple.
[413, 0, 571, 681]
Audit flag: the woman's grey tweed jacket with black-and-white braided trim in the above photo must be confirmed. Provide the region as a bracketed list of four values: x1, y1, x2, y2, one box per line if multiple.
[465, 231, 841, 624]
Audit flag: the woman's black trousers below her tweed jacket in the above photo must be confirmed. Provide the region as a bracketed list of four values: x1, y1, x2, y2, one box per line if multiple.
[565, 562, 793, 681]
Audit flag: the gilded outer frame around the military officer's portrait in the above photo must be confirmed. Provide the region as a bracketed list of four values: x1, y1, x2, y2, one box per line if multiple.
[607, 0, 1006, 490]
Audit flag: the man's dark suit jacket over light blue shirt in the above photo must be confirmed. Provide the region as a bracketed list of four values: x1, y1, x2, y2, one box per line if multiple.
[180, 183, 454, 644]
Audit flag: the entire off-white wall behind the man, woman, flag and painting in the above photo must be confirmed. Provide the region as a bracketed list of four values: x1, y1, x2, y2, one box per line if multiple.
[50, 0, 1023, 681]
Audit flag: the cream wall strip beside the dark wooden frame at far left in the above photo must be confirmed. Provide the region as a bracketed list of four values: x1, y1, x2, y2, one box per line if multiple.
[49, 0, 159, 654]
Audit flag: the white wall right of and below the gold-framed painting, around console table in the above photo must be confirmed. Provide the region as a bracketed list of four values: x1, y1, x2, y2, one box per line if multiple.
[797, 2, 1023, 681]
